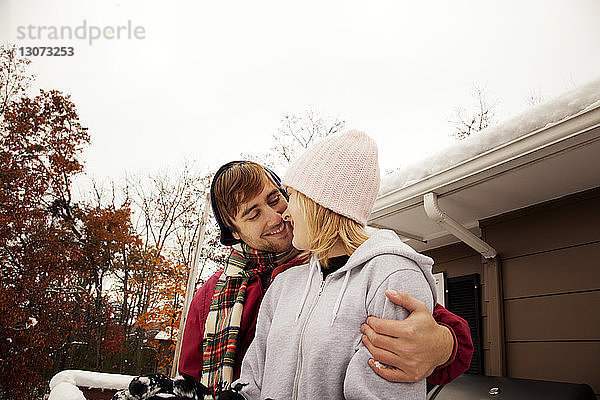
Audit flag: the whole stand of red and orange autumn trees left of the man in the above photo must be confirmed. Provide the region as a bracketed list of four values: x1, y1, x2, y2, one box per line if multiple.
[0, 46, 224, 399]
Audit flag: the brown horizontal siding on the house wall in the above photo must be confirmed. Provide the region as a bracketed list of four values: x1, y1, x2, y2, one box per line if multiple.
[426, 188, 600, 399]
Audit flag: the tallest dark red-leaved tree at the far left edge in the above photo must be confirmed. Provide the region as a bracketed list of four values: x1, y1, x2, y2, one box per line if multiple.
[0, 47, 89, 398]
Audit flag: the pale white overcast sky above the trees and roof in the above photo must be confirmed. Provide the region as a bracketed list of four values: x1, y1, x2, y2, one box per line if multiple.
[0, 0, 600, 188]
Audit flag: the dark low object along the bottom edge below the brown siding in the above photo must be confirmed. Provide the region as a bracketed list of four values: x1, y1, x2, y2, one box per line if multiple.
[427, 374, 596, 400]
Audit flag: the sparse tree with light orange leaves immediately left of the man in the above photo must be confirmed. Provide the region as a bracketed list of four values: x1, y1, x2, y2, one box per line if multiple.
[125, 162, 227, 373]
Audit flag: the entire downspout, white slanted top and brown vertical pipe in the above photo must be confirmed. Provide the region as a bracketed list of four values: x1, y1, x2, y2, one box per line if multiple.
[423, 192, 506, 376]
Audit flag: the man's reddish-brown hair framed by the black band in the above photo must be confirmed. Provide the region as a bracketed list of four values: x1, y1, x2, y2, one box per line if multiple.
[213, 161, 276, 232]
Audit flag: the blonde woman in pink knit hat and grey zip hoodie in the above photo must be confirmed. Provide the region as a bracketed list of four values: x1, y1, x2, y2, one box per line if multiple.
[233, 131, 435, 399]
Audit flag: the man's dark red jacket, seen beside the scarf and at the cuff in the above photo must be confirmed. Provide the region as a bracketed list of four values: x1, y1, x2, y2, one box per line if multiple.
[179, 270, 473, 385]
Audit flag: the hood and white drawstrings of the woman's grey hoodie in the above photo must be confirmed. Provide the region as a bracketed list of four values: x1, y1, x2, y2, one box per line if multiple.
[296, 229, 437, 325]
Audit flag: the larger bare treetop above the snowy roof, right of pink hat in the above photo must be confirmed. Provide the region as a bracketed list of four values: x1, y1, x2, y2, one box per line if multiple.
[450, 85, 497, 139]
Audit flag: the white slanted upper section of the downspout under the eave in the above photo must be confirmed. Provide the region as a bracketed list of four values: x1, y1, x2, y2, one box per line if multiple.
[423, 192, 497, 258]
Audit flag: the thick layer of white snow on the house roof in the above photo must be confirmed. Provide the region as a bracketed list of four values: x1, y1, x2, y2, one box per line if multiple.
[379, 79, 600, 196]
